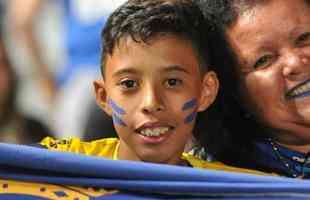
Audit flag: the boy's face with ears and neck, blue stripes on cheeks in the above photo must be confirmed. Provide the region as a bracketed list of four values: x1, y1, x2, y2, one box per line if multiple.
[95, 36, 218, 164]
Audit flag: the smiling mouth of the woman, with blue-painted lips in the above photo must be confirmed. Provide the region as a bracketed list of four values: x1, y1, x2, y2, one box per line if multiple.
[285, 79, 310, 100]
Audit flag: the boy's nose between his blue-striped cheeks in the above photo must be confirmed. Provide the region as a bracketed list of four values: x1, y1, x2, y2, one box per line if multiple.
[142, 88, 164, 114]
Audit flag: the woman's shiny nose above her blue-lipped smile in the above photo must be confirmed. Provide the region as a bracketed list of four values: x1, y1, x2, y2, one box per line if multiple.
[282, 50, 310, 81]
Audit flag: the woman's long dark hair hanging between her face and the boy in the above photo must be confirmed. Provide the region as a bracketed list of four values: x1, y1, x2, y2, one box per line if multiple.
[198, 0, 310, 169]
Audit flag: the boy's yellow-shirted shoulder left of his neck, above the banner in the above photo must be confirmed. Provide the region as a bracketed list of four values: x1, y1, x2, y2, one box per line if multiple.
[40, 137, 119, 159]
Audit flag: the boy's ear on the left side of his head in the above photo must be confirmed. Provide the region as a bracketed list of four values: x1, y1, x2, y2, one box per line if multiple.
[93, 79, 112, 116]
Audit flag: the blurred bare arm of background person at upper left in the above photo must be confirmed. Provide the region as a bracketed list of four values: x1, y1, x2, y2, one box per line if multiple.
[8, 0, 56, 103]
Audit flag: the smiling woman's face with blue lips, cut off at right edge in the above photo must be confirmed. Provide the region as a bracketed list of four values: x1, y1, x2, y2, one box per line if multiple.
[227, 0, 310, 144]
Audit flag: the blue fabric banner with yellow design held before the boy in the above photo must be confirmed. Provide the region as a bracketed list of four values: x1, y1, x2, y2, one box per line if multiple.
[0, 144, 310, 200]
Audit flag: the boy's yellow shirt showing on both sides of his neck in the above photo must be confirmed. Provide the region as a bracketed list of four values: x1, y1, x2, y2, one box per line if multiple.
[40, 137, 268, 175]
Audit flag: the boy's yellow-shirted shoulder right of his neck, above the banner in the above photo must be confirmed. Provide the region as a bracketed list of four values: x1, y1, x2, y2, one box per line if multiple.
[182, 153, 272, 175]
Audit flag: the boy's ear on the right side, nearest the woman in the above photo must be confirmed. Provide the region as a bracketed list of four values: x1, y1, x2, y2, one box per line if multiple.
[198, 71, 219, 112]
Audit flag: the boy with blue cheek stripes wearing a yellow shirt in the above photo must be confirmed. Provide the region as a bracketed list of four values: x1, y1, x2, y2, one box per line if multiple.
[41, 0, 262, 171]
